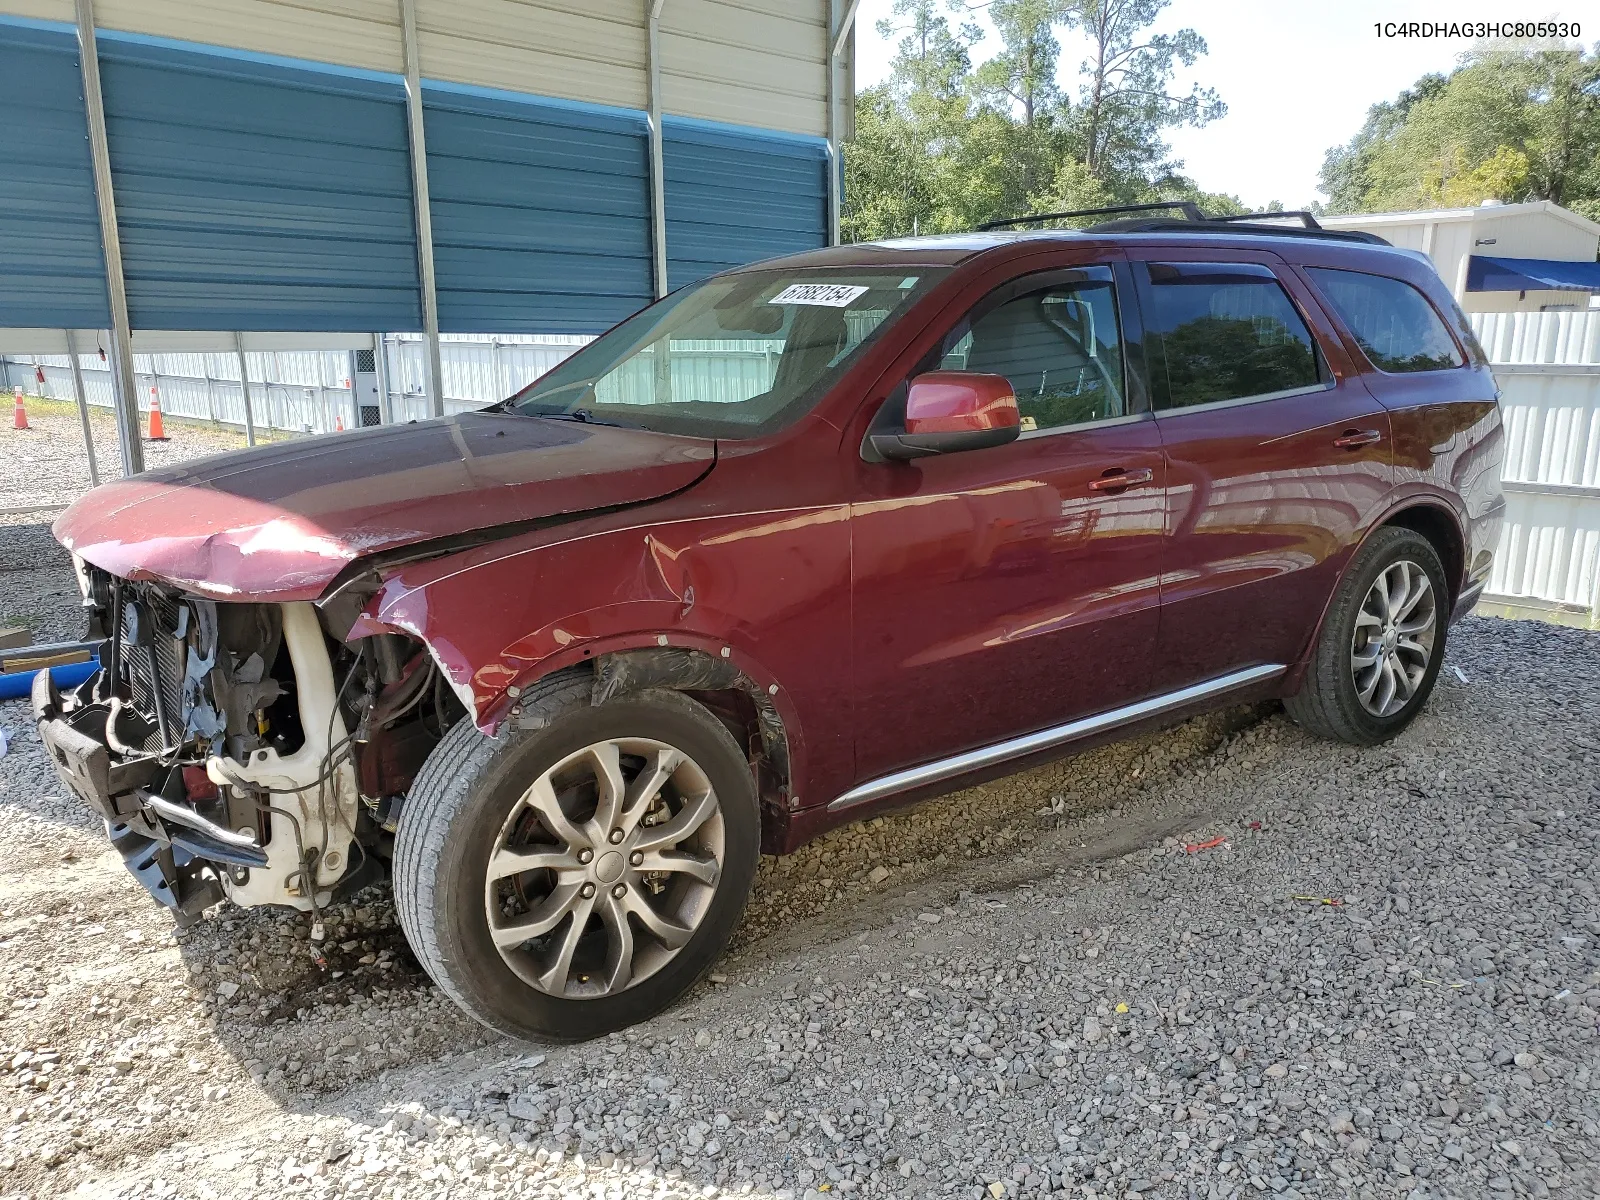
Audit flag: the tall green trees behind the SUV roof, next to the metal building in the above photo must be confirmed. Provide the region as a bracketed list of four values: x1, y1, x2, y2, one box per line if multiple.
[842, 0, 1242, 240]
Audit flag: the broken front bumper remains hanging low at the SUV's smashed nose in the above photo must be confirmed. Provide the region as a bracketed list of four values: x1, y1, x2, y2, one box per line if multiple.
[32, 670, 267, 925]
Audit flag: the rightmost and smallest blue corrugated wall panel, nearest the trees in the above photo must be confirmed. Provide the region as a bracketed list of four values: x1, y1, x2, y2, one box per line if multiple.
[661, 117, 827, 288]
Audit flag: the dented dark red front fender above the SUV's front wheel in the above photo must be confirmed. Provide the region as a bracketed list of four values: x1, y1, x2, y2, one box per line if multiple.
[349, 506, 853, 812]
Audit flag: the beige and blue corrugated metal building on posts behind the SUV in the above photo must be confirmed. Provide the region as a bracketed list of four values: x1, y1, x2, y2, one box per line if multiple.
[0, 0, 856, 470]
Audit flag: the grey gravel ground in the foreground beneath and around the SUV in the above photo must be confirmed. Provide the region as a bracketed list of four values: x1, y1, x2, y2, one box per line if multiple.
[0, 534, 1600, 1200]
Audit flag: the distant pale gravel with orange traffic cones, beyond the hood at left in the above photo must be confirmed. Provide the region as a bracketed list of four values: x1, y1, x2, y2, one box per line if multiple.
[0, 395, 294, 520]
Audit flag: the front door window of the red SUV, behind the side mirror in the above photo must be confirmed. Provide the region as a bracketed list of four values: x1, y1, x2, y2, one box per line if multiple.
[939, 267, 1128, 434]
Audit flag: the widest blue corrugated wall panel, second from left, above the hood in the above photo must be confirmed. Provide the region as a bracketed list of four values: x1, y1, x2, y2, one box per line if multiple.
[99, 32, 422, 331]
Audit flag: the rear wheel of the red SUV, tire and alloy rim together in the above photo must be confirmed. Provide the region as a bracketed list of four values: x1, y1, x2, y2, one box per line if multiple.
[1283, 525, 1450, 746]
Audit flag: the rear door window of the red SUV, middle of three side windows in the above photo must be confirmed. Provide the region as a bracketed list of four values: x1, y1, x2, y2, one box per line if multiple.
[1144, 262, 1323, 408]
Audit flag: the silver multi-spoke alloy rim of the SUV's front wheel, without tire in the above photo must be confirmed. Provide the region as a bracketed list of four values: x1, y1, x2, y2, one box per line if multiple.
[485, 738, 726, 1000]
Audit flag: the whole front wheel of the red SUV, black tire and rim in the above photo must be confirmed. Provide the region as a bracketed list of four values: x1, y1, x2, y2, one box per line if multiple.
[394, 672, 760, 1042]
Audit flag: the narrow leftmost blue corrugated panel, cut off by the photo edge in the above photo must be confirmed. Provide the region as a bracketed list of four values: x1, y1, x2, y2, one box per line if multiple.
[0, 21, 110, 328]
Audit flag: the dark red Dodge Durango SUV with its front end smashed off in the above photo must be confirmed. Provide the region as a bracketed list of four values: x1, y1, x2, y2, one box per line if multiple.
[34, 214, 1502, 1038]
